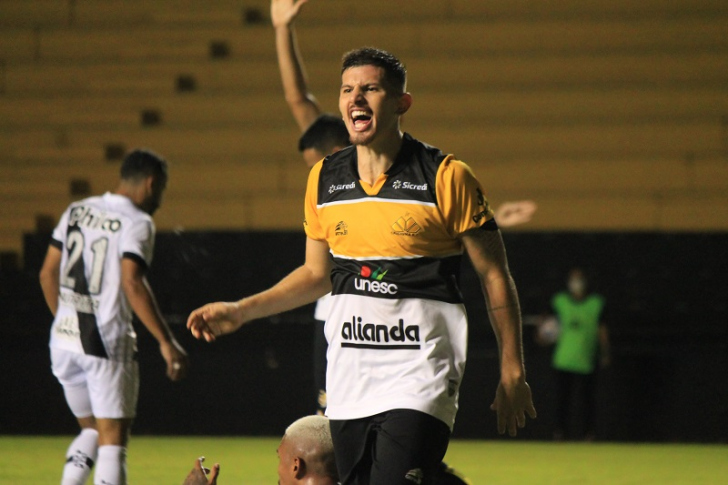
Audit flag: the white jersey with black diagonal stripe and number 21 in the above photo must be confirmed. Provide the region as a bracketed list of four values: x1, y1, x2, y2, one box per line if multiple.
[50, 193, 154, 361]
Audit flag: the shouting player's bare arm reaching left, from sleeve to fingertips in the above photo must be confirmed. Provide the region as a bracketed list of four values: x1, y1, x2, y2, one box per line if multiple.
[187, 238, 331, 342]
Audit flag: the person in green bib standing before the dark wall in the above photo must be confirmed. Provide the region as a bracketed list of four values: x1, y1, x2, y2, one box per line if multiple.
[552, 268, 610, 441]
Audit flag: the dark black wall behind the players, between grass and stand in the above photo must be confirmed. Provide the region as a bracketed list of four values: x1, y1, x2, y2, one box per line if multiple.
[0, 232, 728, 442]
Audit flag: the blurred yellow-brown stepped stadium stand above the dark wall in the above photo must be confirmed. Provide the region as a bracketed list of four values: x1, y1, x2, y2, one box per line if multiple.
[0, 0, 728, 260]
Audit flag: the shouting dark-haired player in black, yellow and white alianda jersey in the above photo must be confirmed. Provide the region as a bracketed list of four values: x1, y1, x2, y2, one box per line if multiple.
[187, 48, 536, 485]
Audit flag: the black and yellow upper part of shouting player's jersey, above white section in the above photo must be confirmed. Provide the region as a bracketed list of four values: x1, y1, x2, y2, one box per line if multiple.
[305, 135, 494, 302]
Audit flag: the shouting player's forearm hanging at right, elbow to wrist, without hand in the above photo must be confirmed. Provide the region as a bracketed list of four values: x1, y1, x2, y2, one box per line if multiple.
[483, 271, 525, 379]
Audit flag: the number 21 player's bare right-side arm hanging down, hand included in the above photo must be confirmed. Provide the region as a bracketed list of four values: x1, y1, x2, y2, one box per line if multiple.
[121, 258, 189, 381]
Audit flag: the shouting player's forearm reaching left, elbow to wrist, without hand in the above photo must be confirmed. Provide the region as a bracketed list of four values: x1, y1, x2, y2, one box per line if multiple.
[237, 265, 331, 323]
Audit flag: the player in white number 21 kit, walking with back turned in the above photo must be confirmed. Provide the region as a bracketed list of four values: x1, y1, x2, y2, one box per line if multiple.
[40, 150, 187, 485]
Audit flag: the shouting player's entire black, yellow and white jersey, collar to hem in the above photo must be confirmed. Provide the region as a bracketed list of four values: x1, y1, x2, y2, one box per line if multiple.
[304, 134, 497, 426]
